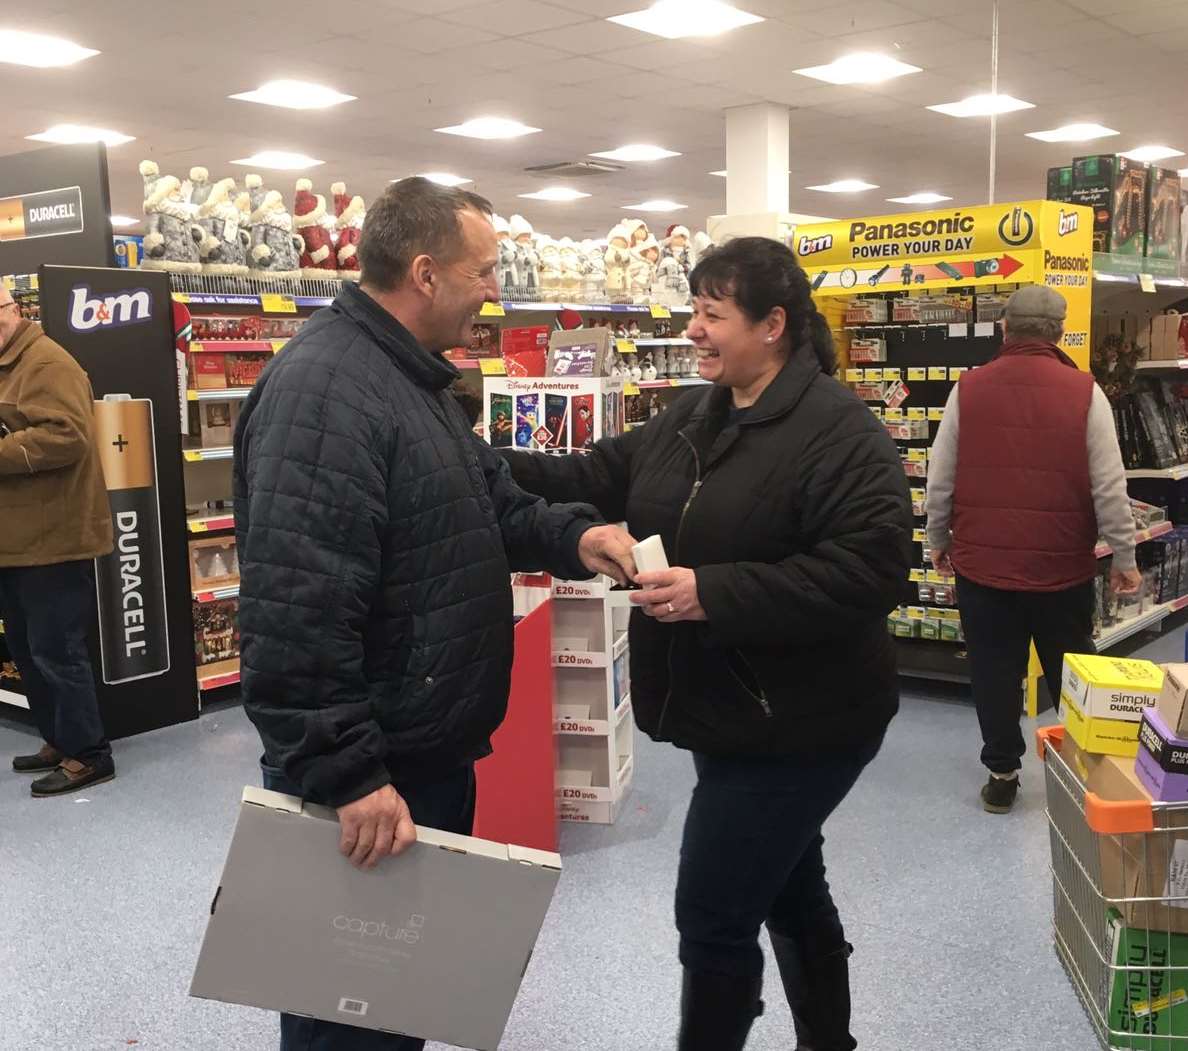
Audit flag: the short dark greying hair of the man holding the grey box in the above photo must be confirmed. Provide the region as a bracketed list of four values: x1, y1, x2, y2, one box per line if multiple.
[359, 176, 493, 292]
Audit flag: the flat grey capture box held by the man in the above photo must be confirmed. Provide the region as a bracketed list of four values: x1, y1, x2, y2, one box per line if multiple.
[190, 787, 561, 1051]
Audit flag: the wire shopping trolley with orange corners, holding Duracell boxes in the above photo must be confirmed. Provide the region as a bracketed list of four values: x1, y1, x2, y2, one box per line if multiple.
[1037, 727, 1188, 1051]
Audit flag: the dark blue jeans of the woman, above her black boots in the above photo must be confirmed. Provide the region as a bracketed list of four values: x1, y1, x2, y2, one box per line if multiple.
[676, 737, 883, 977]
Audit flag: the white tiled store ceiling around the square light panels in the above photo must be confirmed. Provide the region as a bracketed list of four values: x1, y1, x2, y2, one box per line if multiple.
[0, 0, 1188, 236]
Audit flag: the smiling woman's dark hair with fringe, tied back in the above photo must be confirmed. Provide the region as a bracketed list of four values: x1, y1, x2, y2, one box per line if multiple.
[689, 238, 838, 375]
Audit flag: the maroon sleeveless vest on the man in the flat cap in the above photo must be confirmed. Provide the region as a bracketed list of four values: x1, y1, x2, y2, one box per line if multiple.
[950, 341, 1098, 591]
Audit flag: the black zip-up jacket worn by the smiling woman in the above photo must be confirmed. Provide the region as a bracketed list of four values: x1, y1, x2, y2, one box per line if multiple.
[505, 349, 912, 755]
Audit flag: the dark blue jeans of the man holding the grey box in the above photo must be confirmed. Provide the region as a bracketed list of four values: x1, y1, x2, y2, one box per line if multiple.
[260, 760, 475, 1051]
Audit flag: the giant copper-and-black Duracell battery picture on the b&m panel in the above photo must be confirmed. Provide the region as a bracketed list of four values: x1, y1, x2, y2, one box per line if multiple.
[95, 394, 169, 685]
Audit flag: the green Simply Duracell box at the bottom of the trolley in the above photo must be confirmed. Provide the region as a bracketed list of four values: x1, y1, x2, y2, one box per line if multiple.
[1108, 910, 1188, 1051]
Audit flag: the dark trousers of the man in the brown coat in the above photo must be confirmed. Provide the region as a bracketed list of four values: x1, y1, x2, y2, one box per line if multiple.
[0, 562, 112, 764]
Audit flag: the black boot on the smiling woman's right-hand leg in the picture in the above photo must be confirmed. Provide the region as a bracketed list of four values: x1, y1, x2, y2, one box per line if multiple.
[771, 933, 858, 1051]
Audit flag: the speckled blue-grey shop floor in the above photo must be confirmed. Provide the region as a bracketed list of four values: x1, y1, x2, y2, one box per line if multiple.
[0, 694, 1094, 1051]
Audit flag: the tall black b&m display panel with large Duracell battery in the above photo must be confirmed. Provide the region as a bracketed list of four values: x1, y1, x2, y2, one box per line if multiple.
[38, 266, 198, 737]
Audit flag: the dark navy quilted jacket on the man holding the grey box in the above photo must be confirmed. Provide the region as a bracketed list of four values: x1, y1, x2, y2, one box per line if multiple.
[234, 285, 599, 805]
